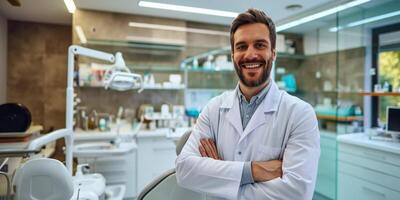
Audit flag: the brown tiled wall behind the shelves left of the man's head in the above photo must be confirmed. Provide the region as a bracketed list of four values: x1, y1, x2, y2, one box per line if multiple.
[73, 10, 229, 118]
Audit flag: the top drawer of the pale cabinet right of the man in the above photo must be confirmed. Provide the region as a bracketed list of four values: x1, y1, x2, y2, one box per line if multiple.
[339, 143, 400, 167]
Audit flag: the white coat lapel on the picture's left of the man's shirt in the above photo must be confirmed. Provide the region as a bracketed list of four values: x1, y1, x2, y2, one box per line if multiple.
[221, 87, 243, 134]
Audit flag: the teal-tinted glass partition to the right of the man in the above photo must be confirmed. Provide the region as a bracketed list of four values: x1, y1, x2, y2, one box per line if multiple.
[282, 0, 400, 199]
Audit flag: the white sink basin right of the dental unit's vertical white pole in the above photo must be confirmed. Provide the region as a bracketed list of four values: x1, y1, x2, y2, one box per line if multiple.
[73, 142, 136, 158]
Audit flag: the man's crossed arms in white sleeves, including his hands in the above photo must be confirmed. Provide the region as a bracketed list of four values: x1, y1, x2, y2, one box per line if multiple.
[176, 101, 319, 200]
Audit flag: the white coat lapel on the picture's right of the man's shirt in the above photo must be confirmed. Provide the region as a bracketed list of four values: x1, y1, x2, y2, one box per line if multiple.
[239, 81, 282, 142]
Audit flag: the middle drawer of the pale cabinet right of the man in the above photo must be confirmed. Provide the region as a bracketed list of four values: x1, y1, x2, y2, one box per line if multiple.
[338, 161, 400, 192]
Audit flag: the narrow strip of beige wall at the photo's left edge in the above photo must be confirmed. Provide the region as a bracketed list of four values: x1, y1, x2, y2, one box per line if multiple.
[0, 15, 7, 104]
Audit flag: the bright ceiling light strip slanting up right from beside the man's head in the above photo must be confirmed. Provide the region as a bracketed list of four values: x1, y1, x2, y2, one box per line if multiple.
[276, 0, 370, 32]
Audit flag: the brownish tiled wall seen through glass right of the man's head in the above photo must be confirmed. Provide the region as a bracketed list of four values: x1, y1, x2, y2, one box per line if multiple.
[277, 47, 365, 107]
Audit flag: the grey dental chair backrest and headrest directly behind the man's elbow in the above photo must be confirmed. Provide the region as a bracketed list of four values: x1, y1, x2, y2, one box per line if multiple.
[137, 130, 205, 200]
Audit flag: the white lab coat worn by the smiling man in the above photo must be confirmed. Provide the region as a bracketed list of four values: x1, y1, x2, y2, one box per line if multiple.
[176, 81, 320, 200]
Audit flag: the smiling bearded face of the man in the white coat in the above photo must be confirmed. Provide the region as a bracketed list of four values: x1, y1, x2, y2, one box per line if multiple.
[232, 23, 275, 87]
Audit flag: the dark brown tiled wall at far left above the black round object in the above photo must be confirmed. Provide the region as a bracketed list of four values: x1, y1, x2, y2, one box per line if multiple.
[7, 21, 72, 130]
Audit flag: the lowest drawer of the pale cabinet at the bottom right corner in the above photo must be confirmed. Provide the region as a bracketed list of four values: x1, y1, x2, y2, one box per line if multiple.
[338, 172, 400, 200]
